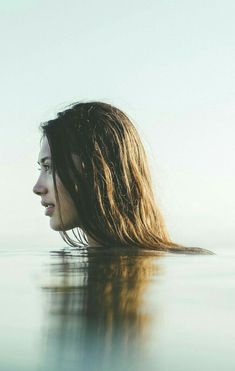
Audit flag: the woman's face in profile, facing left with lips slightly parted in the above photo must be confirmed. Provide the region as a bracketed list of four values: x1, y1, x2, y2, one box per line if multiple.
[33, 136, 80, 231]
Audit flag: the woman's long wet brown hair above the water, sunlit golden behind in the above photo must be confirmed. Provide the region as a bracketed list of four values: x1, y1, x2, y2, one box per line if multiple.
[41, 102, 212, 252]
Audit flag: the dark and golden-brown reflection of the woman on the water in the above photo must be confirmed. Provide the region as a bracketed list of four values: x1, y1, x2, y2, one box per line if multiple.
[40, 250, 161, 371]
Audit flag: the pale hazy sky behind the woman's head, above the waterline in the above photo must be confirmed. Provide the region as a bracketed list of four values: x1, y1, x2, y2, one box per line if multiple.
[0, 0, 235, 253]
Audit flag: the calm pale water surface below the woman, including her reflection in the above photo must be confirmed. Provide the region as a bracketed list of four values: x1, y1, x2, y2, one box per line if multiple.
[0, 249, 235, 371]
